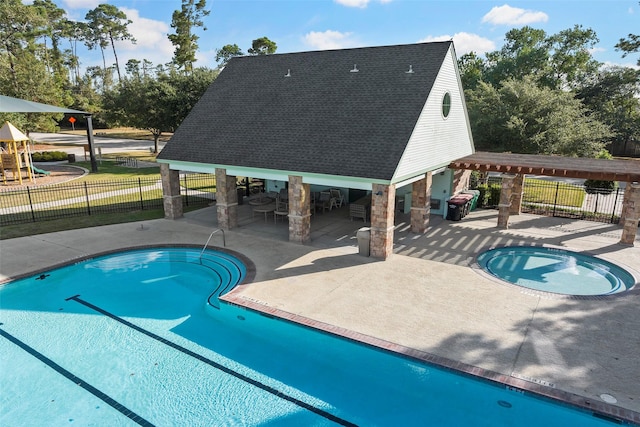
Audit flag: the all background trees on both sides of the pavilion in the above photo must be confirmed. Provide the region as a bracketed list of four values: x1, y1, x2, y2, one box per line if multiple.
[0, 0, 640, 157]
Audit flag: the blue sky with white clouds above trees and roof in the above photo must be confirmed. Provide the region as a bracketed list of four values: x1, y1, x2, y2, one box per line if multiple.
[47, 0, 640, 71]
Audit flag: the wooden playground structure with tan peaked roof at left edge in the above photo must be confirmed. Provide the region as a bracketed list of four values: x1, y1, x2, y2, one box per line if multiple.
[0, 122, 35, 185]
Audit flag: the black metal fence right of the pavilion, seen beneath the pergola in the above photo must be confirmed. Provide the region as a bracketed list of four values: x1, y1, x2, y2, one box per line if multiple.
[477, 176, 624, 224]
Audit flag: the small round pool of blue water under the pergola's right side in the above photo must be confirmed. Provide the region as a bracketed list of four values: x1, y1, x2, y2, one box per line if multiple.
[478, 246, 636, 295]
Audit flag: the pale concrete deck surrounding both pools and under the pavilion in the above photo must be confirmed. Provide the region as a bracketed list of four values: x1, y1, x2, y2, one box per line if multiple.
[0, 205, 640, 423]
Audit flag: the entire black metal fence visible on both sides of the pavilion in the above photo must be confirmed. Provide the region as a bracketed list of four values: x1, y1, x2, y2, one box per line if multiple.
[0, 173, 624, 225]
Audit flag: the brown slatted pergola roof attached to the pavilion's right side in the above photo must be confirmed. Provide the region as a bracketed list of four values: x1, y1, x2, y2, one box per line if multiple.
[449, 152, 640, 182]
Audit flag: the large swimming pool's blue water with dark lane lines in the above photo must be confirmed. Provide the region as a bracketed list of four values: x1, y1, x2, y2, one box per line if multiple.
[0, 248, 628, 427]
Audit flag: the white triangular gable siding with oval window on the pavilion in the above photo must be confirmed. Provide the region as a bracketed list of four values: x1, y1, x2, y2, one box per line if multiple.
[393, 49, 474, 182]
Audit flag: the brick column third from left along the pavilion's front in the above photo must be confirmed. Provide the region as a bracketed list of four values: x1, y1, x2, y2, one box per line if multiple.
[288, 176, 311, 243]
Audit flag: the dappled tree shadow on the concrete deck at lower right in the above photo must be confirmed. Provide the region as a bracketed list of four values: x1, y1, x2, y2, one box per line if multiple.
[422, 289, 640, 408]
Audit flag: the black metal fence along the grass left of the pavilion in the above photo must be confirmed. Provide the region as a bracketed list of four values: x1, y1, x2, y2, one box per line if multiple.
[0, 174, 215, 225]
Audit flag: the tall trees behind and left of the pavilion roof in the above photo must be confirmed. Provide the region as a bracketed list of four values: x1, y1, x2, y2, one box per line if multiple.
[0, 0, 277, 152]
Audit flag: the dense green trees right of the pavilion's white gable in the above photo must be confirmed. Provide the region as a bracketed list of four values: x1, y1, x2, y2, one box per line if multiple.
[458, 19, 640, 157]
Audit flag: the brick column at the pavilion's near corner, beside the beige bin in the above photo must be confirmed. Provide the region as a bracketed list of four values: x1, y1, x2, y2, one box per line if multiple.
[369, 184, 396, 259]
